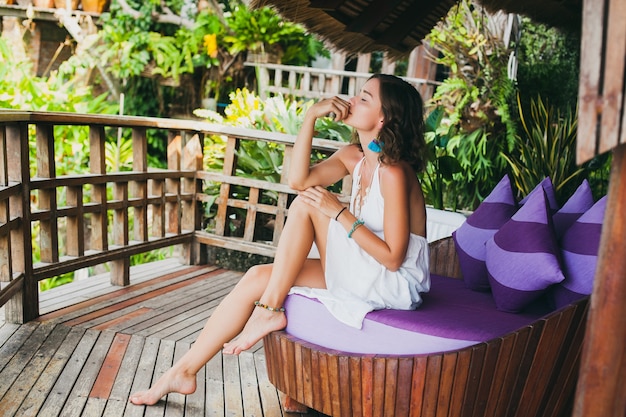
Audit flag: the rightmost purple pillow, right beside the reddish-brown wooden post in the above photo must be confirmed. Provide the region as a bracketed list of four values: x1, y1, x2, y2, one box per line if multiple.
[552, 196, 606, 308]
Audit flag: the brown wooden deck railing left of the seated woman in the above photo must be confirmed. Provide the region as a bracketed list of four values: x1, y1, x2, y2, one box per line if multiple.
[0, 111, 350, 323]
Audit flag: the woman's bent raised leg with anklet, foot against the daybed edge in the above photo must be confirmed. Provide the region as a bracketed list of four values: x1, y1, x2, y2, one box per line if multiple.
[224, 198, 330, 355]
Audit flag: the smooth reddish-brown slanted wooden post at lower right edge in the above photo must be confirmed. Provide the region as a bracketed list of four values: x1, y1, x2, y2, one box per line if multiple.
[573, 145, 626, 417]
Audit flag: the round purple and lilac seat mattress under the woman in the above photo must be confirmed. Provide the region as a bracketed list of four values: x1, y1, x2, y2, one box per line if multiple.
[285, 275, 549, 355]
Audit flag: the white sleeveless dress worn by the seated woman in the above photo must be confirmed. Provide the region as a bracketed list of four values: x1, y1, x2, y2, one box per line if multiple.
[290, 160, 430, 329]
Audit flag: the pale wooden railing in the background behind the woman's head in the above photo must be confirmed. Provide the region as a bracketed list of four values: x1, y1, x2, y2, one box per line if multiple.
[245, 62, 441, 101]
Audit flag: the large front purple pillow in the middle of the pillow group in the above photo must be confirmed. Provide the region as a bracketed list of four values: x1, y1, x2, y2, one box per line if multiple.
[486, 191, 565, 313]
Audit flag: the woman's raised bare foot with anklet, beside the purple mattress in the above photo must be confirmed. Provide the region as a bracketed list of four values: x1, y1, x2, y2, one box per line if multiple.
[223, 308, 287, 355]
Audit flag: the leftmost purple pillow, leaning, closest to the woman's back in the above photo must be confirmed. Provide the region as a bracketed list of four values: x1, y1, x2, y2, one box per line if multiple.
[452, 176, 517, 291]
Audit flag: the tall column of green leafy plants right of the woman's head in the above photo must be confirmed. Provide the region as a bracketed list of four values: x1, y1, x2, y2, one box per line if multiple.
[427, 0, 516, 210]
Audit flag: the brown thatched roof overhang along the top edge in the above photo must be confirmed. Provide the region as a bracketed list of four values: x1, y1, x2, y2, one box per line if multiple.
[252, 0, 582, 56]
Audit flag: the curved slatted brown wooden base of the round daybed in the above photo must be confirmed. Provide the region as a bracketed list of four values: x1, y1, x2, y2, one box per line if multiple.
[264, 238, 588, 417]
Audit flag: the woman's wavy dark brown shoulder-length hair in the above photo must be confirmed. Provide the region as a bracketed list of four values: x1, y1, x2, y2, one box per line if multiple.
[353, 74, 427, 172]
